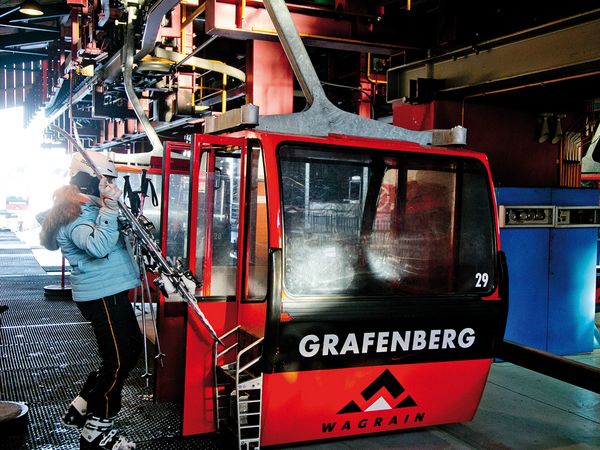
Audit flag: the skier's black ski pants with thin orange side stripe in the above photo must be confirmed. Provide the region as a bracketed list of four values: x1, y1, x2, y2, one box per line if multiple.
[75, 291, 143, 419]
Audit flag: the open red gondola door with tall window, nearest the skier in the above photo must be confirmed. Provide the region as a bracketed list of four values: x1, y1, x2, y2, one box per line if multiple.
[183, 135, 247, 436]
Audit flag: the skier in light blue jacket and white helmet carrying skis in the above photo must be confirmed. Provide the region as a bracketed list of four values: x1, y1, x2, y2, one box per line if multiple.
[40, 152, 143, 450]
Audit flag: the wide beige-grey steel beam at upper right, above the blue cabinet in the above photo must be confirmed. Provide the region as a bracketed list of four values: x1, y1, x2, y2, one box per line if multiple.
[387, 14, 600, 102]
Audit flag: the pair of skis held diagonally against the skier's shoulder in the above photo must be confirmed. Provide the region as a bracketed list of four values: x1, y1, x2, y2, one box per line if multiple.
[50, 124, 222, 344]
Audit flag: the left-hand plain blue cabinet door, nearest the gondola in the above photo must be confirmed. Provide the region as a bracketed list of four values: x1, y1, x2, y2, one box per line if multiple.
[500, 228, 550, 350]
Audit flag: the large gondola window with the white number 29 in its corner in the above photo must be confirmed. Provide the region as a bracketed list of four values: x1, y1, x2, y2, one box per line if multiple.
[280, 145, 495, 296]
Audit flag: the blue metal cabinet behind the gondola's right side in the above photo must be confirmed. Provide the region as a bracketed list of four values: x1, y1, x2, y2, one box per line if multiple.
[496, 188, 599, 355]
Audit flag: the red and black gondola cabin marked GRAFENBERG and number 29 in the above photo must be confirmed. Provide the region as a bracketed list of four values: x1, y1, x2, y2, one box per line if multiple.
[159, 131, 507, 448]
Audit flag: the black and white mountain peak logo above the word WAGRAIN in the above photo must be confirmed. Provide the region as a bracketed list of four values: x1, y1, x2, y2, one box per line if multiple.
[337, 369, 418, 414]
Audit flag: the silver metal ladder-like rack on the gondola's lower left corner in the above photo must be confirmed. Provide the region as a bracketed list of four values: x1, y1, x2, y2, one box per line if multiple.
[214, 325, 263, 450]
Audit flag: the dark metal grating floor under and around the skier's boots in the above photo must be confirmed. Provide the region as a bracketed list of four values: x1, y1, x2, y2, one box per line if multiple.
[0, 233, 225, 450]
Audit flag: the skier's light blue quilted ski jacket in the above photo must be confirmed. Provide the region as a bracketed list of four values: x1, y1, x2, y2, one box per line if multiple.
[56, 201, 140, 302]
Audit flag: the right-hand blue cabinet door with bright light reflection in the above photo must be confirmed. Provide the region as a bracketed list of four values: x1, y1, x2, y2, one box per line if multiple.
[548, 228, 598, 355]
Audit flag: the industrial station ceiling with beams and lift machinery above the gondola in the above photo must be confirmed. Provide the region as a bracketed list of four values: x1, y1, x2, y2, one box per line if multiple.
[0, 0, 600, 163]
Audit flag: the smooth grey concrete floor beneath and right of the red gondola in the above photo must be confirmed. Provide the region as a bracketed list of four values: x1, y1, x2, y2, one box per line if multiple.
[0, 230, 600, 450]
